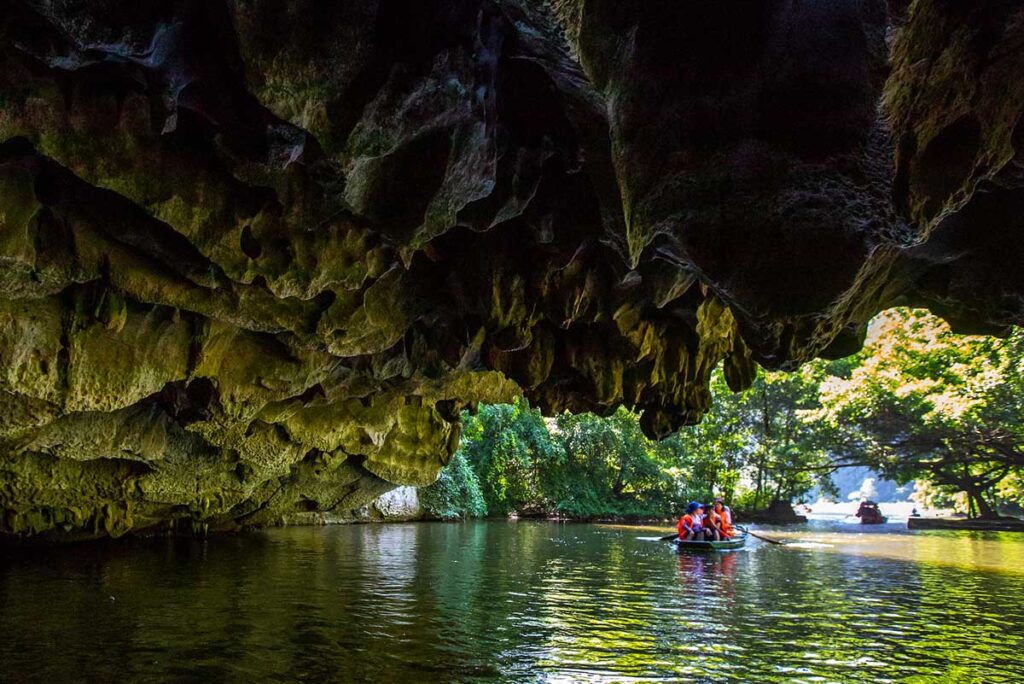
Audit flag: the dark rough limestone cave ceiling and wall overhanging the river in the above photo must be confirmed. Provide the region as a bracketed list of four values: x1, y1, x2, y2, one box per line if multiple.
[0, 0, 1024, 538]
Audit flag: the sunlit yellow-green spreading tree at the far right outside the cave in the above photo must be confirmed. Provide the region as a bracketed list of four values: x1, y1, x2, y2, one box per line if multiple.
[817, 309, 1024, 518]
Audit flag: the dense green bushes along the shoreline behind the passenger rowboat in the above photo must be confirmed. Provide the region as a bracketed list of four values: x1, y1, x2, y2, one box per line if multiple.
[419, 399, 815, 525]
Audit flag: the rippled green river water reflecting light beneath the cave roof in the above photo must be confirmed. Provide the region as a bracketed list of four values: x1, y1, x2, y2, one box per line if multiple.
[0, 521, 1024, 684]
